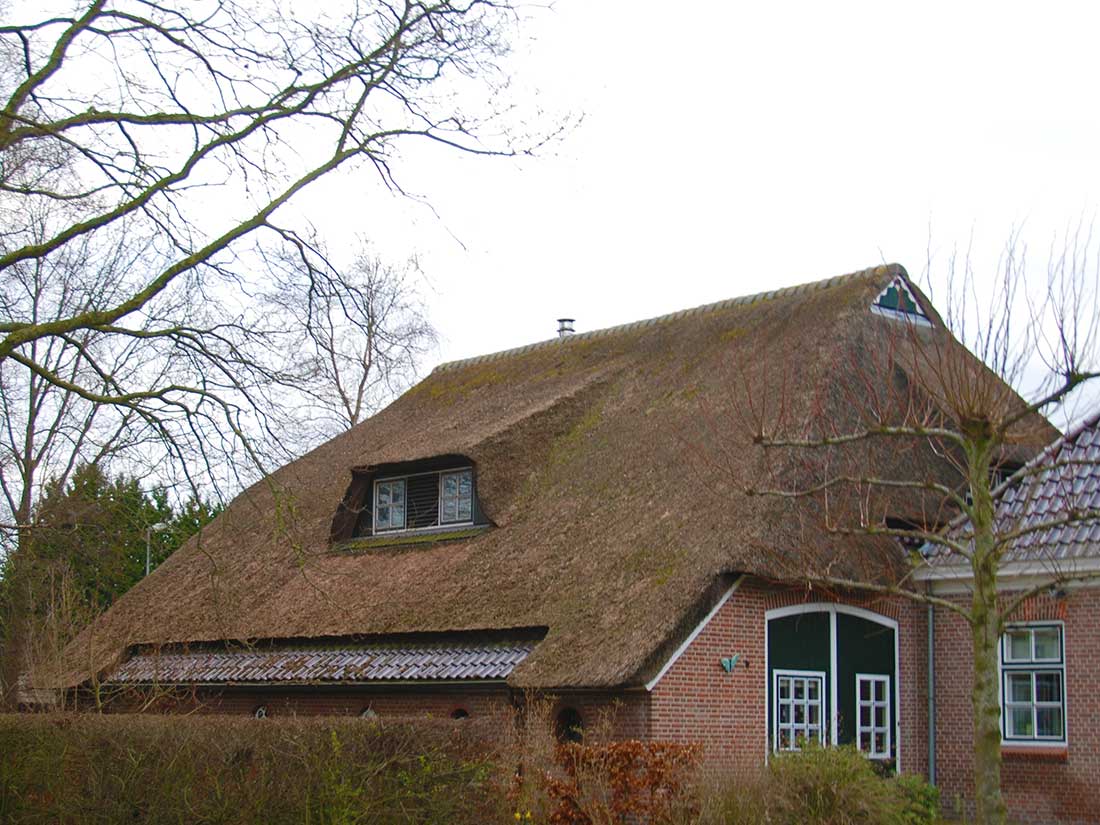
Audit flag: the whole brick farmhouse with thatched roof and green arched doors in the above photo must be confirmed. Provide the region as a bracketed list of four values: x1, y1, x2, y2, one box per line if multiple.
[53, 265, 1100, 822]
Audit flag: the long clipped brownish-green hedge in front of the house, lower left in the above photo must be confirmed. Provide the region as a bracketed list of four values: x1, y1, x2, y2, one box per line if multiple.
[0, 715, 498, 825]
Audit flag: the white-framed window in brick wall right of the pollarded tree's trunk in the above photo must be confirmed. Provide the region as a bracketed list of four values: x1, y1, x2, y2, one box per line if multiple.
[1001, 623, 1066, 744]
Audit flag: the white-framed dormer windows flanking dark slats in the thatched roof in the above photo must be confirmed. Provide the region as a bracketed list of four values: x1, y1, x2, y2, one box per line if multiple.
[371, 466, 476, 535]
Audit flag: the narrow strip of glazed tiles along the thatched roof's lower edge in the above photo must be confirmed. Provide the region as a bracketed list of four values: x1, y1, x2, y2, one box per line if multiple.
[107, 640, 536, 684]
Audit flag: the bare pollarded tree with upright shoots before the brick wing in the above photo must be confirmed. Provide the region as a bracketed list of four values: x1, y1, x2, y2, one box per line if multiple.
[735, 250, 1100, 824]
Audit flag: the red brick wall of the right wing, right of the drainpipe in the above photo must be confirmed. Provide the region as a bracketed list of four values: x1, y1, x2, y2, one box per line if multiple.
[936, 589, 1100, 823]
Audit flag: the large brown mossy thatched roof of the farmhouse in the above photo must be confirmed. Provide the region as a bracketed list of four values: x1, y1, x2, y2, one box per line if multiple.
[53, 266, 1056, 688]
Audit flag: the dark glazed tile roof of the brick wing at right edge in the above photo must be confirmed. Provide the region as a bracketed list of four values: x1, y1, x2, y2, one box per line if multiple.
[998, 414, 1100, 562]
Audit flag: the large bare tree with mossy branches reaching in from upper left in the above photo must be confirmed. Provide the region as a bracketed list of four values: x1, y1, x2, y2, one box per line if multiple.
[0, 0, 536, 490]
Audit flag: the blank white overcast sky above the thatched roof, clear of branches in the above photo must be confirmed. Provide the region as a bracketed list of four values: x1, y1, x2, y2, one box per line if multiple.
[290, 0, 1100, 415]
